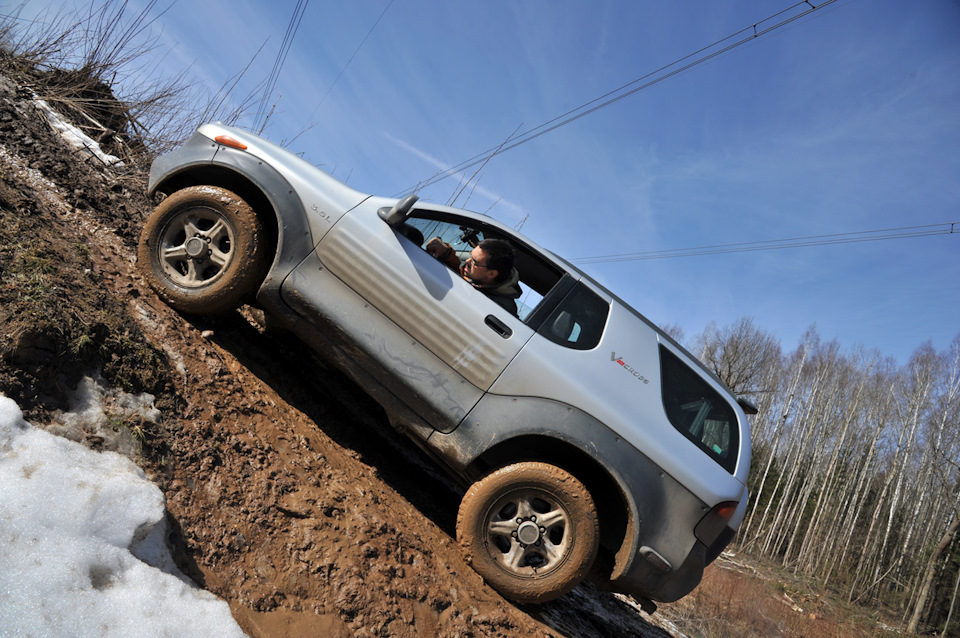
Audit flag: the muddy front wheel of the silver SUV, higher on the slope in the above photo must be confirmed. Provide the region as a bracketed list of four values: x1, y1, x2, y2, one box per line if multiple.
[137, 186, 269, 314]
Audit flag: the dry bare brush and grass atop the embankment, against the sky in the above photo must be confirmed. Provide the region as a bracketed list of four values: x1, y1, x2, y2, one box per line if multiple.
[0, 0, 262, 160]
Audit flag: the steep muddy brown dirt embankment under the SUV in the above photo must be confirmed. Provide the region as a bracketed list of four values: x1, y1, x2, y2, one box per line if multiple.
[0, 72, 667, 638]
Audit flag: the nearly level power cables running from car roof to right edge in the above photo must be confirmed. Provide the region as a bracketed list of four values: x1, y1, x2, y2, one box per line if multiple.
[570, 222, 960, 264]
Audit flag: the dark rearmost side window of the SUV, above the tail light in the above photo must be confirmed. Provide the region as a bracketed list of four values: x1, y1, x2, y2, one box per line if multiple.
[660, 346, 740, 474]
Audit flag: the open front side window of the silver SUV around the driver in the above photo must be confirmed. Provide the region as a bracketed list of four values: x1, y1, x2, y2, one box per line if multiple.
[397, 210, 563, 321]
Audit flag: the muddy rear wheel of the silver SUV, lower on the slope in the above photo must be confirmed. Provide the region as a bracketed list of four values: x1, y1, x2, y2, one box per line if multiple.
[457, 462, 600, 603]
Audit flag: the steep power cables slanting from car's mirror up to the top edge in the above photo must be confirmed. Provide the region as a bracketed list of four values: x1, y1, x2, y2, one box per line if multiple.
[397, 0, 838, 196]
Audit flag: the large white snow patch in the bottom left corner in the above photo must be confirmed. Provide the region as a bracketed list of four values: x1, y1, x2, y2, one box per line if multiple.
[0, 395, 244, 638]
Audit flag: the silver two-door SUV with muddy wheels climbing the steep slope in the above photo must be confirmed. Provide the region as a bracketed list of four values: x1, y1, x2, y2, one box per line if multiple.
[138, 124, 752, 611]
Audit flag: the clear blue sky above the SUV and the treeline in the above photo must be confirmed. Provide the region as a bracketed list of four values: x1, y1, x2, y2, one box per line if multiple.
[18, 0, 960, 363]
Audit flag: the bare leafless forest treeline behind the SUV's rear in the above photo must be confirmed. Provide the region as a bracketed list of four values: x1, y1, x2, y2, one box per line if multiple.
[690, 318, 960, 635]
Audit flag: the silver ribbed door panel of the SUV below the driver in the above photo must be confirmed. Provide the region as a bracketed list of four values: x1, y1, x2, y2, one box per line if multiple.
[294, 200, 533, 431]
